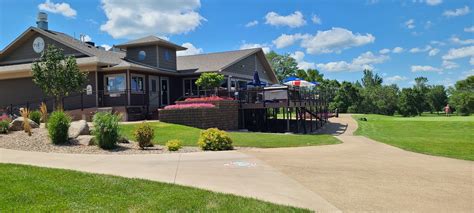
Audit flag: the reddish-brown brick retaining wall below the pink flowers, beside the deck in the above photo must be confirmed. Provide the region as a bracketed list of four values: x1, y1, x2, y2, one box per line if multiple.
[158, 101, 239, 130]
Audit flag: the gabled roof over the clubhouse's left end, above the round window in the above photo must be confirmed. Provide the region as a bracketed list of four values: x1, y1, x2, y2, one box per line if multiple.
[0, 27, 125, 64]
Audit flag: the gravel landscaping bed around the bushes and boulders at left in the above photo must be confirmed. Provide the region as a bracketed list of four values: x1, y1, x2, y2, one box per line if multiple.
[0, 128, 201, 154]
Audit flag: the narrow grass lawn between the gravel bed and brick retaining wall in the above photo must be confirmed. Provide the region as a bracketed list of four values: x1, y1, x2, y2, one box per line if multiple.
[120, 122, 340, 148]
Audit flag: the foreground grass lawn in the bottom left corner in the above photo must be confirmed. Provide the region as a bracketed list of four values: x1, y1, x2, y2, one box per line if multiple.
[0, 164, 309, 212]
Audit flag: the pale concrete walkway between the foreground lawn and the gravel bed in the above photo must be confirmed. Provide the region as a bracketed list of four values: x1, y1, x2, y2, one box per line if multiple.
[0, 149, 339, 212]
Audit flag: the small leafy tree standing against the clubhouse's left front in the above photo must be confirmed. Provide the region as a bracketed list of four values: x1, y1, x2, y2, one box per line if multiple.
[32, 45, 87, 110]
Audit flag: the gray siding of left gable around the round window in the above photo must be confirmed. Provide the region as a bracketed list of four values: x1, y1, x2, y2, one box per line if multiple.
[0, 33, 85, 65]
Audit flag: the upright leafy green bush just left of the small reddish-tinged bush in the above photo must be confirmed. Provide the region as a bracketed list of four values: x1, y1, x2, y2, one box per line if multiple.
[93, 112, 120, 149]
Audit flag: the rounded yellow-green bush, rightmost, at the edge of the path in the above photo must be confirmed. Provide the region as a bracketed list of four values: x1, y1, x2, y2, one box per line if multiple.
[198, 128, 233, 151]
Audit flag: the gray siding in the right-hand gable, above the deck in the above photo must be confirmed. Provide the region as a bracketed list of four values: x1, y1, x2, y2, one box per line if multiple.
[223, 54, 270, 83]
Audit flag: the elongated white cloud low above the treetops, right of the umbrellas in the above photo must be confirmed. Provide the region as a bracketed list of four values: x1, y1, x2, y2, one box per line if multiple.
[316, 51, 390, 72]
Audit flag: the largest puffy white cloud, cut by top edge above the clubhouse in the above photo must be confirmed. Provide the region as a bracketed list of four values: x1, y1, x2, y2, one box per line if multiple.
[100, 0, 206, 38]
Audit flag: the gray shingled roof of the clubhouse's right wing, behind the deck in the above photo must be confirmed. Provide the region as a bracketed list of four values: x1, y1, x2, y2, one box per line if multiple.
[177, 48, 278, 82]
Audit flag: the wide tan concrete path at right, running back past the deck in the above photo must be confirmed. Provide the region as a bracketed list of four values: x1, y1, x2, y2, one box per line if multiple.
[245, 115, 474, 212]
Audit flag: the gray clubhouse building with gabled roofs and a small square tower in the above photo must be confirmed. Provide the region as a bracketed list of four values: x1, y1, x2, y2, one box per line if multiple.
[0, 13, 278, 118]
